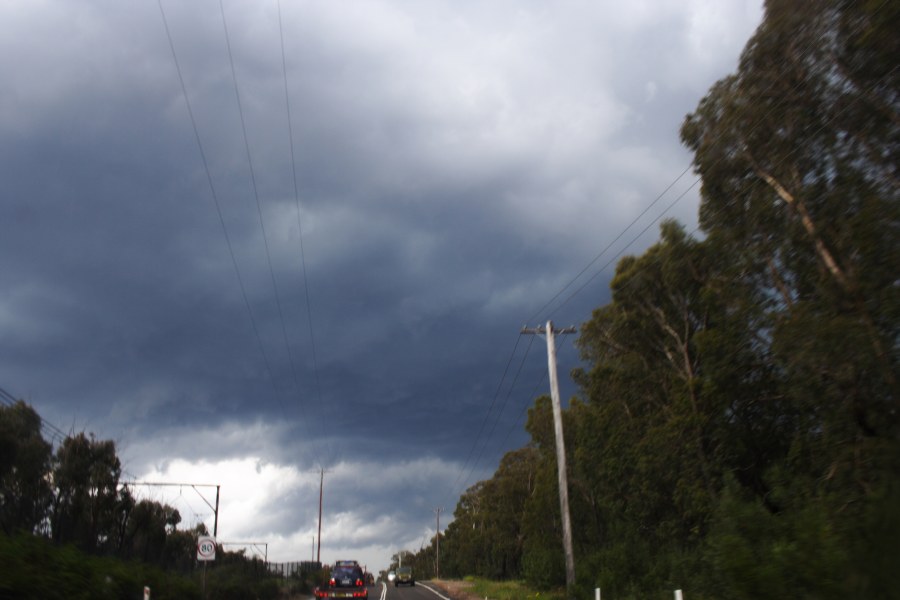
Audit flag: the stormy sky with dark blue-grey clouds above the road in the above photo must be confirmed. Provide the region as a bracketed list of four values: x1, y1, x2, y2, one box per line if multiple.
[0, 0, 762, 570]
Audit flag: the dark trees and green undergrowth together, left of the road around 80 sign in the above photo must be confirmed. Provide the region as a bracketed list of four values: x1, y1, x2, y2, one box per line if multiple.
[0, 401, 288, 599]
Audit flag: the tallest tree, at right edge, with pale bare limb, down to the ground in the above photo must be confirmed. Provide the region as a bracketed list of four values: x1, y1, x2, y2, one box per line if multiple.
[682, 0, 900, 596]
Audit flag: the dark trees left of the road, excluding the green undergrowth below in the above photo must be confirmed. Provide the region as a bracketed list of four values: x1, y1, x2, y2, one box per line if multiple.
[0, 401, 199, 571]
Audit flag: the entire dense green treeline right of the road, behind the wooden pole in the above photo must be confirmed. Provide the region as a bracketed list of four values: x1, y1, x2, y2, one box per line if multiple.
[417, 0, 900, 599]
